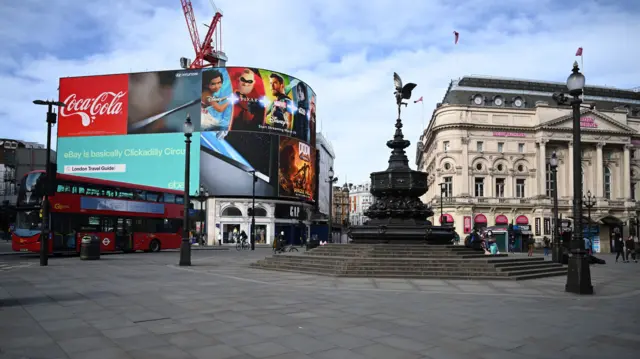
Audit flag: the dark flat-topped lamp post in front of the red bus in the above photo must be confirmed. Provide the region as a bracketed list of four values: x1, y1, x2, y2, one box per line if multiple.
[33, 100, 65, 266]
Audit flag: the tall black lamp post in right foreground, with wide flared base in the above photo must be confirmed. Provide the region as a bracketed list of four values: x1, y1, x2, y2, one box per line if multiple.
[565, 62, 593, 294]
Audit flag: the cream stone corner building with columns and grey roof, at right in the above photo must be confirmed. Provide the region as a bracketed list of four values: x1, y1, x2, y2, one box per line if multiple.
[416, 76, 640, 252]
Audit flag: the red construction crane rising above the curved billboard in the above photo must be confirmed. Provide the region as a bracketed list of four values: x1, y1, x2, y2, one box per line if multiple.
[180, 0, 227, 69]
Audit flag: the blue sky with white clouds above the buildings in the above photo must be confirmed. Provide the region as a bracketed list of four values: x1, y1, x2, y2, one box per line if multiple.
[0, 0, 640, 183]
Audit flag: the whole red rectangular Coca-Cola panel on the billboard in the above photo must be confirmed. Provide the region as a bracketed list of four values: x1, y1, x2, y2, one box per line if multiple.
[58, 74, 129, 137]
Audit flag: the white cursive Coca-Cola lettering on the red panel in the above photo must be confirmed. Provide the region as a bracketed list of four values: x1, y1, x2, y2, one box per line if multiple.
[60, 91, 127, 127]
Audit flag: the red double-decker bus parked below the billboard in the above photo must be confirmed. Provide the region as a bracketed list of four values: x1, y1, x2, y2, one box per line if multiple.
[11, 171, 184, 254]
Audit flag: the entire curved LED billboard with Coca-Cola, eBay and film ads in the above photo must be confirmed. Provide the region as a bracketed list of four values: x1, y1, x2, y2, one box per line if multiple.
[58, 67, 316, 201]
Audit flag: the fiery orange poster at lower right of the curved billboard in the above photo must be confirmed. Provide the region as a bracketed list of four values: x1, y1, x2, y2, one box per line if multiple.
[278, 136, 316, 201]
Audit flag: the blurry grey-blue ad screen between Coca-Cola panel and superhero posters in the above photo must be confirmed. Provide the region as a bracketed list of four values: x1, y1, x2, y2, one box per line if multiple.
[127, 70, 202, 134]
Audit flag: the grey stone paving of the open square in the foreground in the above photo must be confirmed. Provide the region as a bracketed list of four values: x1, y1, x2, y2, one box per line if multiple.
[0, 249, 640, 359]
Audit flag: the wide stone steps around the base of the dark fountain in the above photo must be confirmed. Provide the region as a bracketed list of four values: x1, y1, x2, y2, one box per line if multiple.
[251, 244, 567, 280]
